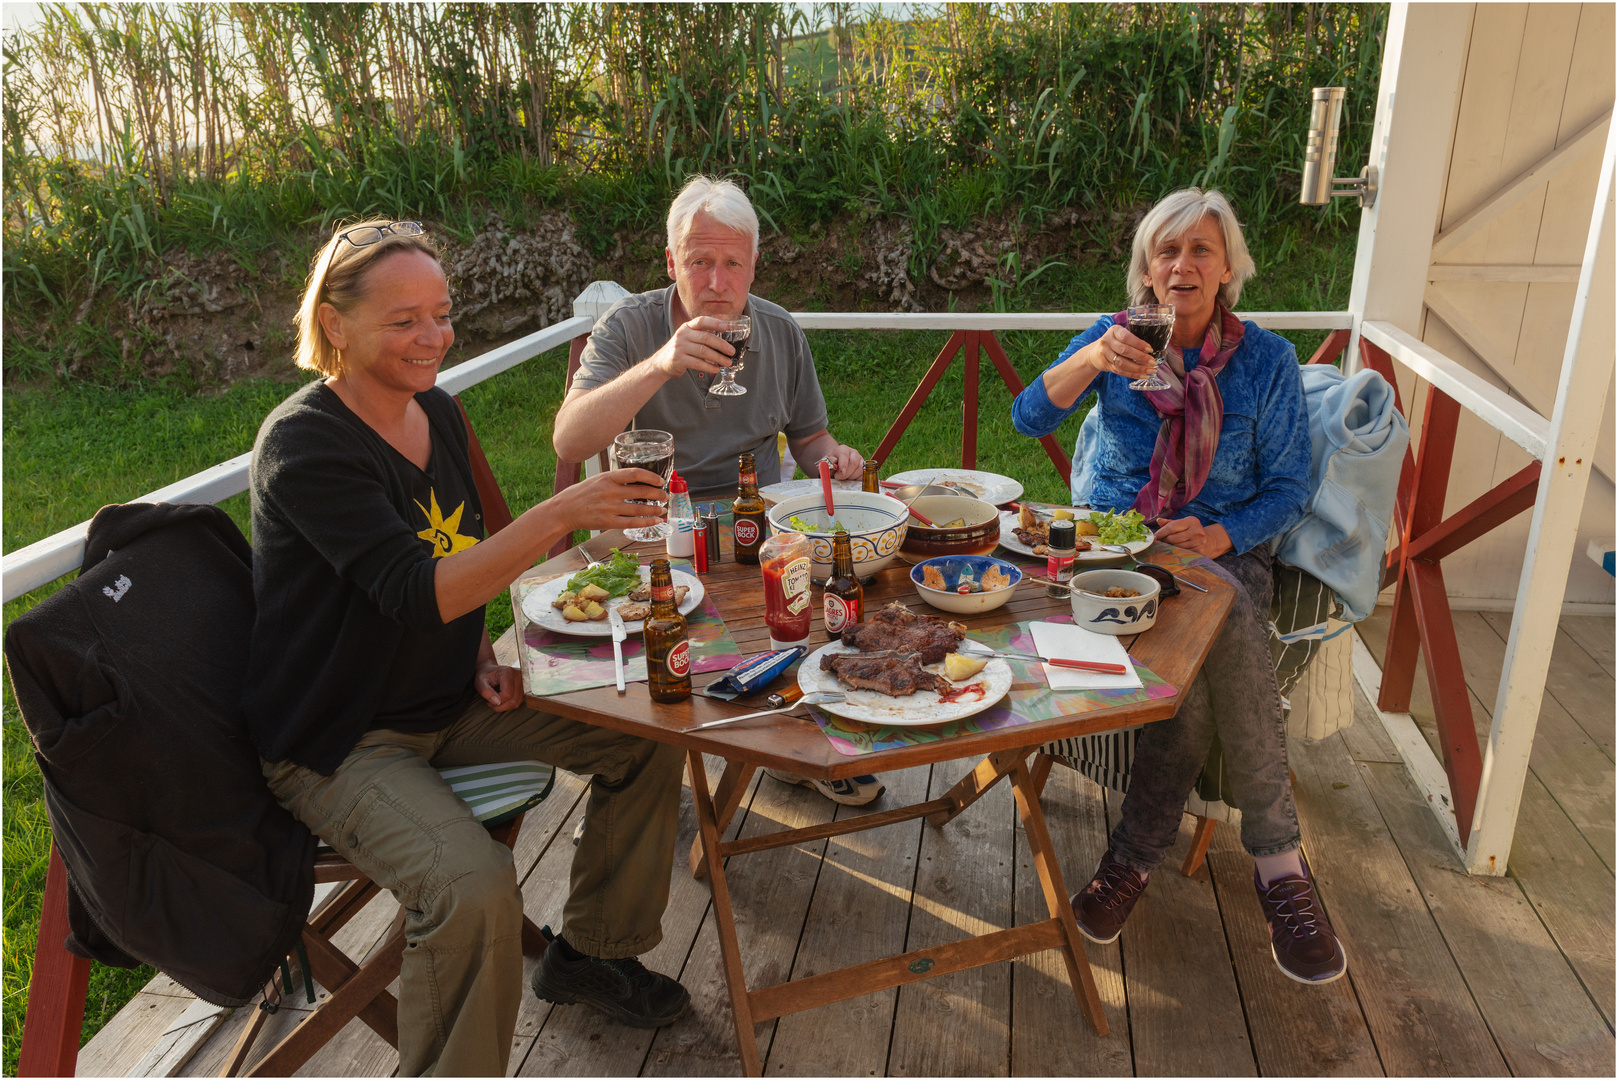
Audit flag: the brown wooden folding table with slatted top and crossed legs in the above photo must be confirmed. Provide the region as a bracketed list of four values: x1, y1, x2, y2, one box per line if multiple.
[527, 534, 1233, 1075]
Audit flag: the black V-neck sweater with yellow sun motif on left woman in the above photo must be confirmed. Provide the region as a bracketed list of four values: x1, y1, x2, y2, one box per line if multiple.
[243, 381, 484, 776]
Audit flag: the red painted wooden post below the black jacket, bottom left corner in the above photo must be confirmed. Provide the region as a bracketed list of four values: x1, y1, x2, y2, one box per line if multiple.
[16, 844, 91, 1077]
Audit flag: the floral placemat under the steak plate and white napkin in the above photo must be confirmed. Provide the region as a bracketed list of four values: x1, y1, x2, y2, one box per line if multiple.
[809, 615, 1178, 756]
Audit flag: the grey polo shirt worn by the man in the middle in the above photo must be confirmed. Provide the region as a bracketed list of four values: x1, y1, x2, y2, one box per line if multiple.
[573, 285, 827, 502]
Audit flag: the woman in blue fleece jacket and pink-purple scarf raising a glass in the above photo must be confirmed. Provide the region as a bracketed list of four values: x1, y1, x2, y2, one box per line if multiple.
[1011, 188, 1348, 983]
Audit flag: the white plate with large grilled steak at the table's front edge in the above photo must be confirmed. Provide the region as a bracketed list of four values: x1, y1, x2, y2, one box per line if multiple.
[798, 647, 1011, 727]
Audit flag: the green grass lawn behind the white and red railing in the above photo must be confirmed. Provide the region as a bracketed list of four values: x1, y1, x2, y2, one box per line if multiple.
[3, 236, 1354, 1075]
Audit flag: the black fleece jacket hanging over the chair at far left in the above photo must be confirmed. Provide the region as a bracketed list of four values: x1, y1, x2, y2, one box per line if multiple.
[5, 504, 314, 1006]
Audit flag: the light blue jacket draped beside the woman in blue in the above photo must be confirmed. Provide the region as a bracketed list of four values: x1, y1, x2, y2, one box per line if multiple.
[1275, 364, 1411, 622]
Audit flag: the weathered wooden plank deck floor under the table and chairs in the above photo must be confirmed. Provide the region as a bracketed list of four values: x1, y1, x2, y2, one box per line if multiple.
[79, 614, 1615, 1077]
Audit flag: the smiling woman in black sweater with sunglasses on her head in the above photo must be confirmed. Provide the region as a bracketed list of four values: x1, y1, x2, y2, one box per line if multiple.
[243, 220, 689, 1075]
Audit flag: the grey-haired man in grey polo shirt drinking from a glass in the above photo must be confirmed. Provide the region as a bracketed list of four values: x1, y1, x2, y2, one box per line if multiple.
[552, 176, 883, 806]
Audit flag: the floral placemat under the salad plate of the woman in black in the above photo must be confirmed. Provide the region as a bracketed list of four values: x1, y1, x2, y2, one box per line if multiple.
[511, 559, 741, 698]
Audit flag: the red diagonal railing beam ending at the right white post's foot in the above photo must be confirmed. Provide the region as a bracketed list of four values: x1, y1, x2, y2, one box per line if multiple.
[1404, 560, 1484, 844]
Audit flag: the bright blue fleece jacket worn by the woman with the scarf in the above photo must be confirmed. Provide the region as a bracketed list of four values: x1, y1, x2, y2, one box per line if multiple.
[1011, 317, 1309, 554]
